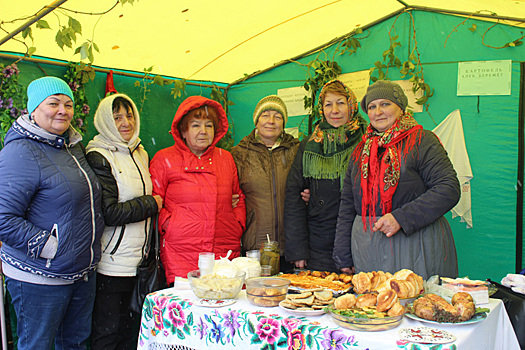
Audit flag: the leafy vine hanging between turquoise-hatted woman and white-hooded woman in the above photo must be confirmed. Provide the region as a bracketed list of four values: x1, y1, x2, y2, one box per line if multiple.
[65, 62, 95, 135]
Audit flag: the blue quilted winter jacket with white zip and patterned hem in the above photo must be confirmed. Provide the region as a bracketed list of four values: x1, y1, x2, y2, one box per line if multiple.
[0, 115, 104, 280]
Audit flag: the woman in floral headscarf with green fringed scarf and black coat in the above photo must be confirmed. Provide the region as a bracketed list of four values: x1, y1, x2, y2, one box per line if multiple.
[284, 80, 366, 271]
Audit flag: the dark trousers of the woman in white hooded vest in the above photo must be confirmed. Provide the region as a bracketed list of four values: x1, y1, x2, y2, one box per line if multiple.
[91, 274, 139, 350]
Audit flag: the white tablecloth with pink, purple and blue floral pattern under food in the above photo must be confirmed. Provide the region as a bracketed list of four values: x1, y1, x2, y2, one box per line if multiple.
[138, 288, 519, 350]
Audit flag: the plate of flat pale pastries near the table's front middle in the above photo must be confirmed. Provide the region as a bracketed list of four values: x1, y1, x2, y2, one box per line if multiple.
[279, 290, 335, 317]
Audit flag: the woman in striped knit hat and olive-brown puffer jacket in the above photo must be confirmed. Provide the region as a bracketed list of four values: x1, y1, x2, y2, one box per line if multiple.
[231, 95, 299, 271]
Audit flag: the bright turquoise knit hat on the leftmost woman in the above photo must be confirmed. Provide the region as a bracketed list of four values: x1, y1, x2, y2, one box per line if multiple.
[27, 77, 75, 114]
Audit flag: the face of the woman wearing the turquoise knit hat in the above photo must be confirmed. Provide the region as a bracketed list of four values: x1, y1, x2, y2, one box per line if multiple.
[31, 94, 75, 135]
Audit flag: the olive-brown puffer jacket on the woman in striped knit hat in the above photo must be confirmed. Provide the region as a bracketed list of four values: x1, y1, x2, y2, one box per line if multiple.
[231, 130, 299, 255]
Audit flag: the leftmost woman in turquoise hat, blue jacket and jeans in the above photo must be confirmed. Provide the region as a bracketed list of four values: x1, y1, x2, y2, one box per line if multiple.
[0, 77, 104, 350]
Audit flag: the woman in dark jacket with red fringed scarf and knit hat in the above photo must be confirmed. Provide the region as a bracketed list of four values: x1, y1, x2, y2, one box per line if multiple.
[333, 80, 460, 279]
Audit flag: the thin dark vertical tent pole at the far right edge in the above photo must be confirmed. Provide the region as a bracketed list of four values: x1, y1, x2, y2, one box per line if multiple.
[516, 62, 525, 273]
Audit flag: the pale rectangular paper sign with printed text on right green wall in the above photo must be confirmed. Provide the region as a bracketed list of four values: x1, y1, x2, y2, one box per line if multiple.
[457, 60, 512, 96]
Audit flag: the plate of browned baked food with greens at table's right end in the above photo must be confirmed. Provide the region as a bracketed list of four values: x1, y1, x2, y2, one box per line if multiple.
[406, 292, 490, 325]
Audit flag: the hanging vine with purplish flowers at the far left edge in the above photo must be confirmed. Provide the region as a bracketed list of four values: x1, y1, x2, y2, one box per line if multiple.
[0, 63, 27, 148]
